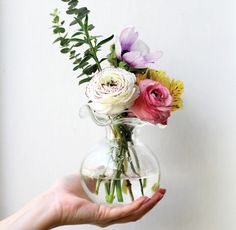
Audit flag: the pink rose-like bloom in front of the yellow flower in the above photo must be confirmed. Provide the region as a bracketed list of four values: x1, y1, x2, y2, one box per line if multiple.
[130, 79, 172, 125]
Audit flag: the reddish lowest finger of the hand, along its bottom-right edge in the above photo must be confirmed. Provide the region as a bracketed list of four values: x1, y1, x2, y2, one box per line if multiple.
[107, 189, 166, 224]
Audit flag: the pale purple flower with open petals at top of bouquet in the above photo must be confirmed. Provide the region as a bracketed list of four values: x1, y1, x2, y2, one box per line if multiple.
[115, 27, 162, 68]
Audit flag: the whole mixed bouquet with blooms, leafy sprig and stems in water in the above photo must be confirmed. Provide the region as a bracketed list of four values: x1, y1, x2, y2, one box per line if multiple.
[51, 0, 184, 203]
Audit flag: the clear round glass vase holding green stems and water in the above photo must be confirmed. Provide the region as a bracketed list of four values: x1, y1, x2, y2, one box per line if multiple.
[80, 118, 160, 205]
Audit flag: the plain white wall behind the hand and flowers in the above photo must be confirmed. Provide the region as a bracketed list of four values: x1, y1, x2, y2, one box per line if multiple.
[0, 0, 236, 230]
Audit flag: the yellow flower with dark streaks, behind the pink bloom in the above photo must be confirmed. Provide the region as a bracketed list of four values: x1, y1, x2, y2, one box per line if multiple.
[136, 69, 184, 111]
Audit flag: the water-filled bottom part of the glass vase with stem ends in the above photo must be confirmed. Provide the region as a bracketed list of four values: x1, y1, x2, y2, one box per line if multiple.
[82, 173, 159, 206]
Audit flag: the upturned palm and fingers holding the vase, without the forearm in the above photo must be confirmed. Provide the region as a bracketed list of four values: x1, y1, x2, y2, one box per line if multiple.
[50, 175, 165, 227]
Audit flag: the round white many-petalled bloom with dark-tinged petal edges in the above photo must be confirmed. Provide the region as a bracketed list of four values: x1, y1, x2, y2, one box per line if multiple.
[86, 67, 139, 115]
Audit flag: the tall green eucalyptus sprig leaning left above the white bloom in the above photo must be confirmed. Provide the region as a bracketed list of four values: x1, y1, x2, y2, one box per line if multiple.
[51, 0, 114, 84]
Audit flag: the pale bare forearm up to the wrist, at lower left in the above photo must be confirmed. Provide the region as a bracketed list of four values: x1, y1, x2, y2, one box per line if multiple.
[0, 193, 56, 230]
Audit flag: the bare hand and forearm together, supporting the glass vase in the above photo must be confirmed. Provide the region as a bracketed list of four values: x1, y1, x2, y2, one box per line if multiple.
[0, 174, 166, 230]
